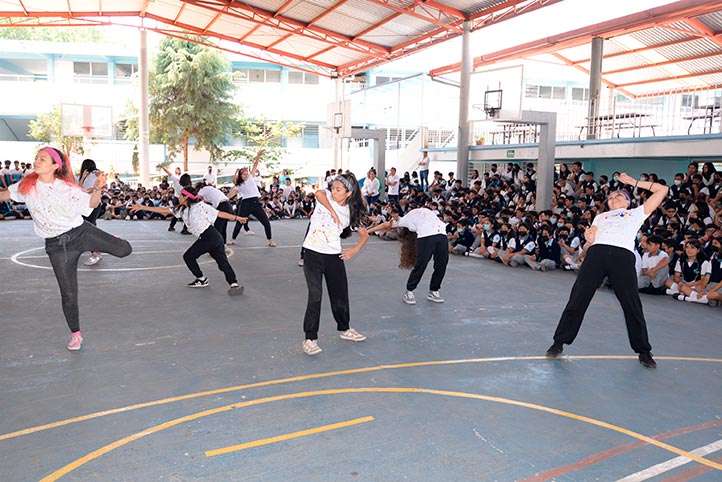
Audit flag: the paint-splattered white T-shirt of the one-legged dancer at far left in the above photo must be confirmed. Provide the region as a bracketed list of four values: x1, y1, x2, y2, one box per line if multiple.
[8, 179, 93, 238]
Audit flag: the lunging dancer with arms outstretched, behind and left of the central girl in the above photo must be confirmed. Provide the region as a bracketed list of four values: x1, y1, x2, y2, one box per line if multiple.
[130, 187, 247, 296]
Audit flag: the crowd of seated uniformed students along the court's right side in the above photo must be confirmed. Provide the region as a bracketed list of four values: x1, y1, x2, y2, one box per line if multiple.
[371, 162, 722, 305]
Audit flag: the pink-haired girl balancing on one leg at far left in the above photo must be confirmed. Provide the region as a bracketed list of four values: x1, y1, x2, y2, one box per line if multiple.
[0, 147, 132, 350]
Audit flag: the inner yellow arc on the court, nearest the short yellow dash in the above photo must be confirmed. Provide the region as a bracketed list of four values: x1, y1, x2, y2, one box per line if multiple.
[40, 387, 722, 482]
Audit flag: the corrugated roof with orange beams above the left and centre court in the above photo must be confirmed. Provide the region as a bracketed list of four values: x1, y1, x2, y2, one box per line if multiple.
[0, 0, 562, 77]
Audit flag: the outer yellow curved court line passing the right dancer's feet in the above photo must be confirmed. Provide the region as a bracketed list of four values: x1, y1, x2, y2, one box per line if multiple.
[0, 355, 722, 441]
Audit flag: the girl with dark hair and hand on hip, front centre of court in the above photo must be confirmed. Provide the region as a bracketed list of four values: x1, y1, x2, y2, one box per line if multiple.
[303, 173, 369, 355]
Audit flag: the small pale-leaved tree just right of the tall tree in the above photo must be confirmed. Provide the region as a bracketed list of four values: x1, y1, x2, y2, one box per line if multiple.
[223, 117, 303, 171]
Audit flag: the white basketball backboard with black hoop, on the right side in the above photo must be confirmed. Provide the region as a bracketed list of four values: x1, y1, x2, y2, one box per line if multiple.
[469, 65, 524, 122]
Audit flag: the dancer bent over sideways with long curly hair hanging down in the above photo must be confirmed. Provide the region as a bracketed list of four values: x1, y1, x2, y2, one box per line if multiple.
[368, 207, 449, 305]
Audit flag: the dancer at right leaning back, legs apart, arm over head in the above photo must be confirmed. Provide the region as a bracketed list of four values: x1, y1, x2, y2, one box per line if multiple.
[546, 173, 668, 368]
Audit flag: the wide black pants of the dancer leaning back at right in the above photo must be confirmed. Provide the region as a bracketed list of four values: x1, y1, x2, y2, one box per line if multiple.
[554, 244, 652, 353]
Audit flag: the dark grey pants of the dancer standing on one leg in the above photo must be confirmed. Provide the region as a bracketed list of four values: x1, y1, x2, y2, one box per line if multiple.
[45, 223, 133, 333]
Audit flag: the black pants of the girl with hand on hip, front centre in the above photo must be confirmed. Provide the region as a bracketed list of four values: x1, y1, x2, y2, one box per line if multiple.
[303, 249, 350, 340]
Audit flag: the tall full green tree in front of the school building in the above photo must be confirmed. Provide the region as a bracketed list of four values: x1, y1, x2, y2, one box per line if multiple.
[148, 37, 240, 171]
